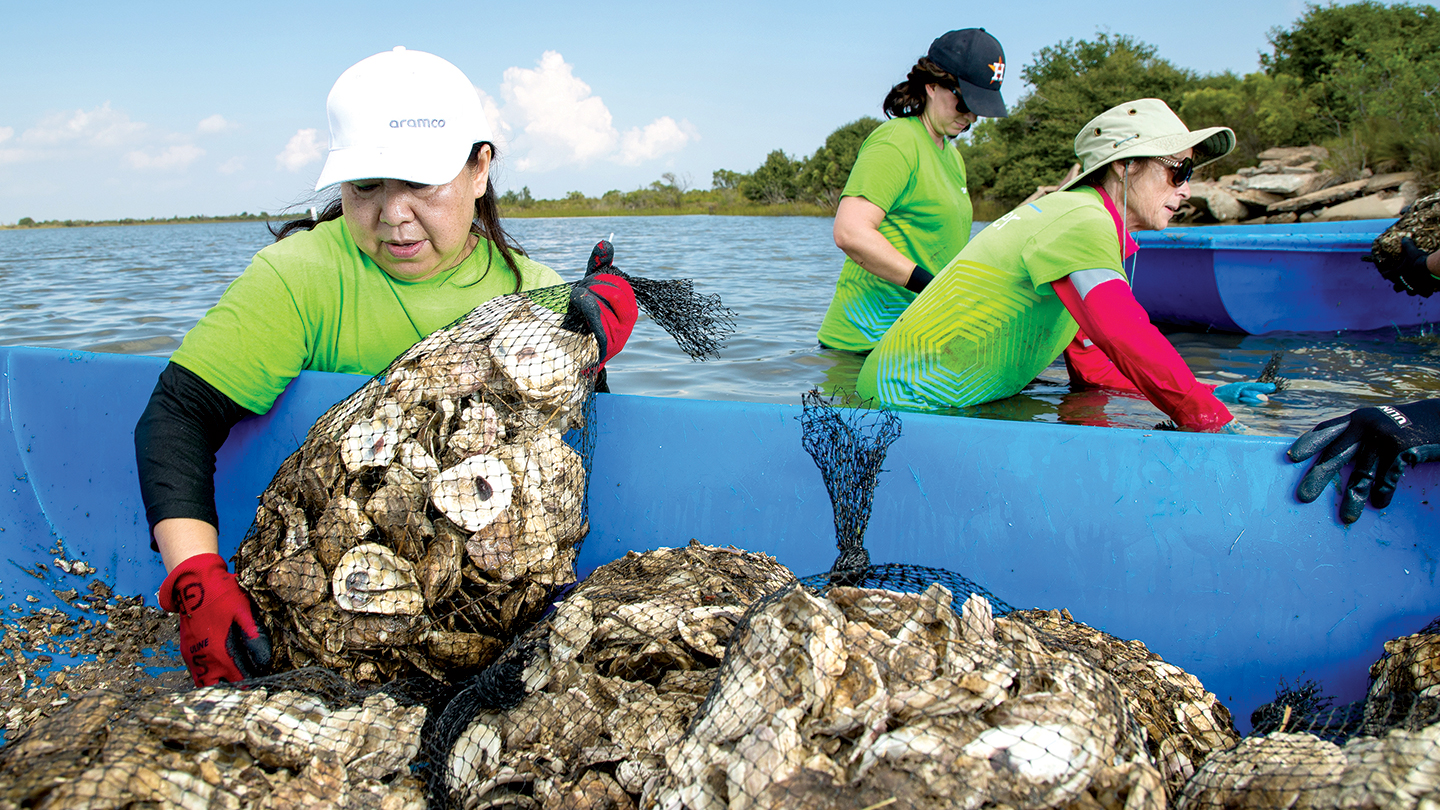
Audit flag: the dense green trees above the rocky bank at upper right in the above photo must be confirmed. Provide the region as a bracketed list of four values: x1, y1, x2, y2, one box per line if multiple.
[960, 0, 1440, 213]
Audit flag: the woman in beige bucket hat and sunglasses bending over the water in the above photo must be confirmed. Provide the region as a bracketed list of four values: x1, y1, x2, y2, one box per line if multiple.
[857, 98, 1274, 431]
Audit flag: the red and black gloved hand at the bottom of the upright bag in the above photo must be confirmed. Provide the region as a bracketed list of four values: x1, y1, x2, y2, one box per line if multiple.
[160, 553, 271, 686]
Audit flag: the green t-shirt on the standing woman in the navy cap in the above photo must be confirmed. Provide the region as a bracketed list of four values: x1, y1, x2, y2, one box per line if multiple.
[818, 117, 973, 352]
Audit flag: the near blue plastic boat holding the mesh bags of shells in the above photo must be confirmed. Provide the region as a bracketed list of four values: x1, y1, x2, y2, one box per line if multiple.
[0, 343, 1440, 728]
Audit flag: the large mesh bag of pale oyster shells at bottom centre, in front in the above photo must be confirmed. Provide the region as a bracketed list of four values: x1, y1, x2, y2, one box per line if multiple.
[641, 584, 1165, 810]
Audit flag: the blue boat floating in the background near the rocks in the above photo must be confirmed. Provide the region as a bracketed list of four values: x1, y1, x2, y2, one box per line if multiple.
[1133, 219, 1440, 334]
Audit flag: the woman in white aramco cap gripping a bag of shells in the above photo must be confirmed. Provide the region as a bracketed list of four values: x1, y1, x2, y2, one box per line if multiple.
[135, 48, 636, 685]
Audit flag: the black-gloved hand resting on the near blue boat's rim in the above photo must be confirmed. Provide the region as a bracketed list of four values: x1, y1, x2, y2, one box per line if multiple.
[1287, 399, 1440, 523]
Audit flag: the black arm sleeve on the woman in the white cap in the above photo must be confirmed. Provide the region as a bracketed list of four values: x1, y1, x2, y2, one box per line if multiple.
[135, 363, 253, 551]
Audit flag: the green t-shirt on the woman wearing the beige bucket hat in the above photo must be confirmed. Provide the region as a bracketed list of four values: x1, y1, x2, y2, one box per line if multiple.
[855, 186, 1125, 409]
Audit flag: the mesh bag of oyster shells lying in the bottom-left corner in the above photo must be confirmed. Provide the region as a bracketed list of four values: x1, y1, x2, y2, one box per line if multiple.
[0, 670, 426, 810]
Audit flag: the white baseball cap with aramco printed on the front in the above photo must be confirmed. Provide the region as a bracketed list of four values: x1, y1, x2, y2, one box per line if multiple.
[315, 48, 494, 192]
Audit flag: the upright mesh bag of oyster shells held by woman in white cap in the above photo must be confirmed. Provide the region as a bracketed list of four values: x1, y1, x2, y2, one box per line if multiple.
[235, 257, 732, 683]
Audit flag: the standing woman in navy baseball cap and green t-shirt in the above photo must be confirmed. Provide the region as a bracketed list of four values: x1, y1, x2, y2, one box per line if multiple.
[818, 29, 1005, 352]
